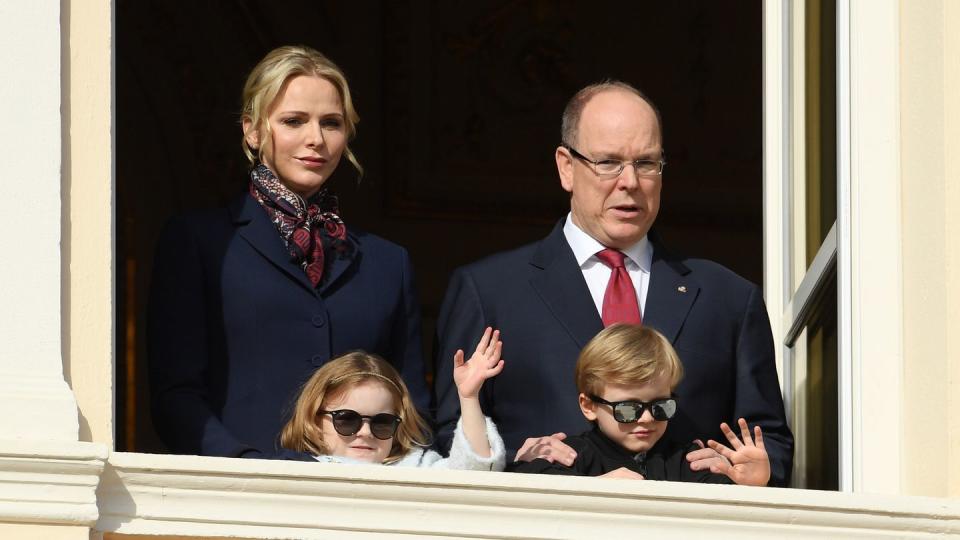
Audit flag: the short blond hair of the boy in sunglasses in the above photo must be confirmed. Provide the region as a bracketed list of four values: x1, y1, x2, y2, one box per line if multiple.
[574, 324, 683, 396]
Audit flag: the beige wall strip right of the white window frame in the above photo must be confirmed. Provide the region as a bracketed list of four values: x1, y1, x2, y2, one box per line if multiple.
[900, 2, 950, 496]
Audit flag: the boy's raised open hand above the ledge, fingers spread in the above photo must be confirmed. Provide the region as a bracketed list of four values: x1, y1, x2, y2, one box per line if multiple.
[707, 418, 770, 486]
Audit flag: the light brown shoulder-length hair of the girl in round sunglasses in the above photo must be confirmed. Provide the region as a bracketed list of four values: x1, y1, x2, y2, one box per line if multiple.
[280, 351, 430, 463]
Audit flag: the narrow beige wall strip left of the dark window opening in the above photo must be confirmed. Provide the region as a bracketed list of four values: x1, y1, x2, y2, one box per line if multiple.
[61, 0, 114, 447]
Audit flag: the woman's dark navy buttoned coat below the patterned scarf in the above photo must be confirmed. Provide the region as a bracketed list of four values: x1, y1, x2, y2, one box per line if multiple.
[147, 195, 429, 457]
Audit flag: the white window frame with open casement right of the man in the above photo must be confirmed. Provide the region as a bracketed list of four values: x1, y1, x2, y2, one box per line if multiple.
[763, 0, 904, 493]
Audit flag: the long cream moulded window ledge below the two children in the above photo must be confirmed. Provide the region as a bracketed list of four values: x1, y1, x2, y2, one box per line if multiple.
[96, 453, 960, 539]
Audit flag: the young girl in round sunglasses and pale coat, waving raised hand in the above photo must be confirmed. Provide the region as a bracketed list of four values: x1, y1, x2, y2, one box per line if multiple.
[280, 328, 505, 471]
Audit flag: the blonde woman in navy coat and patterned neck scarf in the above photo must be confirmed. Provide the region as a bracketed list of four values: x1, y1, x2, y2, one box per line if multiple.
[148, 47, 429, 459]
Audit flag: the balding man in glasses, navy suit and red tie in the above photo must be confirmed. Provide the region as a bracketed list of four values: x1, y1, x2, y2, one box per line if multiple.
[435, 81, 793, 485]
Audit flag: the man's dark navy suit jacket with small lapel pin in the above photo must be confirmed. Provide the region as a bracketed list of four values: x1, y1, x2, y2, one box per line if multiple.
[435, 220, 793, 485]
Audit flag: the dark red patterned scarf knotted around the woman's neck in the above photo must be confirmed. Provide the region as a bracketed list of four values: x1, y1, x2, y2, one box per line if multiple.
[250, 163, 353, 287]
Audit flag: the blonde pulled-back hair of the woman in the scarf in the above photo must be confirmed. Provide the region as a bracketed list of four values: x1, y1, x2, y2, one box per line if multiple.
[240, 45, 363, 175]
